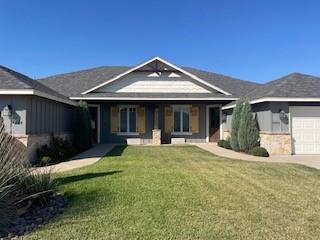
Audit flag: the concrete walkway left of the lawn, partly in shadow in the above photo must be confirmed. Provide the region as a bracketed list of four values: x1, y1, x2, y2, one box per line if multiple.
[34, 144, 115, 172]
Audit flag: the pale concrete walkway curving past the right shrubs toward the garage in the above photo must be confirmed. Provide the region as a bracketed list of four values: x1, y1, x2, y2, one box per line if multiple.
[194, 143, 320, 169]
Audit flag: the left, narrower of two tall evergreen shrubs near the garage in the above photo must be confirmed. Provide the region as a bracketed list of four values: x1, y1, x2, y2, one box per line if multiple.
[230, 100, 243, 151]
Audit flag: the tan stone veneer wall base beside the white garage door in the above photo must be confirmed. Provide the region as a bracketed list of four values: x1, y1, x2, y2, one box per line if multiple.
[260, 132, 292, 154]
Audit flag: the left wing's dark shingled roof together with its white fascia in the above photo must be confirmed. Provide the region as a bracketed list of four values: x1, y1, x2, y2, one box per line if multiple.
[0, 65, 76, 105]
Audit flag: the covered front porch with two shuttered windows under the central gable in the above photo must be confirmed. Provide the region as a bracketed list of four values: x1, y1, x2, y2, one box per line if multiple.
[88, 101, 224, 145]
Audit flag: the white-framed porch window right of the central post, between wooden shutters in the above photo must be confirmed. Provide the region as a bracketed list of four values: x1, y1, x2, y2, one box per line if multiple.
[173, 106, 190, 133]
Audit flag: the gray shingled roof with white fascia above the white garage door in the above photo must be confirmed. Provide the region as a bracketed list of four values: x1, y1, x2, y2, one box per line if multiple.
[223, 73, 320, 109]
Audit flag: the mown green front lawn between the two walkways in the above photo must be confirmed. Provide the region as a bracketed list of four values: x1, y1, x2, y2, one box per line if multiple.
[26, 146, 320, 240]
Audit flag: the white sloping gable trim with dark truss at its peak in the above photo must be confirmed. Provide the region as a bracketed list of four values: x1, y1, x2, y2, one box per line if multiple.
[82, 57, 231, 95]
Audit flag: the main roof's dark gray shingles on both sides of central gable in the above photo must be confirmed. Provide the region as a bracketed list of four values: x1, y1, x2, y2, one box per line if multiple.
[39, 66, 259, 97]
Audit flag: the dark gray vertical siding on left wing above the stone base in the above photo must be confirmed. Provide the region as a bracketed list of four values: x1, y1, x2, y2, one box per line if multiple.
[0, 96, 75, 135]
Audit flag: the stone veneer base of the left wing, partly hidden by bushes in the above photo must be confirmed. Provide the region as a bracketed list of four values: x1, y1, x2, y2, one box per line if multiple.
[13, 133, 71, 163]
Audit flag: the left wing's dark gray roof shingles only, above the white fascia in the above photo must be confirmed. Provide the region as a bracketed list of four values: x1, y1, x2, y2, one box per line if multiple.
[0, 65, 72, 100]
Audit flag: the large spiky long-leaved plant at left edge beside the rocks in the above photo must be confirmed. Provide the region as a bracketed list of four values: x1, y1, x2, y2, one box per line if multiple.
[0, 118, 56, 230]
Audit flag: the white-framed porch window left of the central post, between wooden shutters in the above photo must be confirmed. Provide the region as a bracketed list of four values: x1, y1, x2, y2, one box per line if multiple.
[119, 107, 137, 133]
